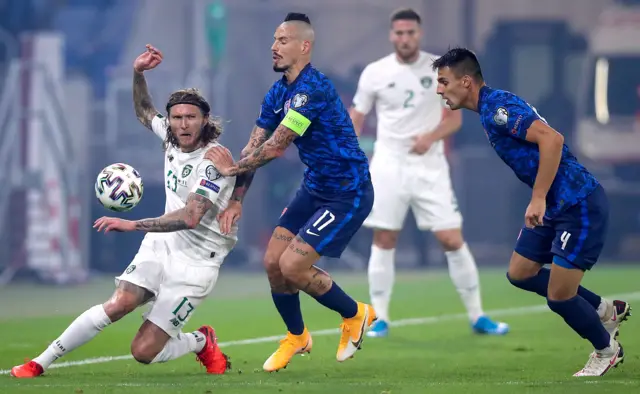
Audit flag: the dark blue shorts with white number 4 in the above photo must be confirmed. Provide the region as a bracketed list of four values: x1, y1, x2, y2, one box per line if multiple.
[515, 186, 609, 271]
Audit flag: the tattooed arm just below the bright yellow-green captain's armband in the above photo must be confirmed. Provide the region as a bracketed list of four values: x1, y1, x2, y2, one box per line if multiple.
[229, 124, 298, 176]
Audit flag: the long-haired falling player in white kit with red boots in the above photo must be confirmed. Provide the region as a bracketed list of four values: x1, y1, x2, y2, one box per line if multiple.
[11, 45, 232, 378]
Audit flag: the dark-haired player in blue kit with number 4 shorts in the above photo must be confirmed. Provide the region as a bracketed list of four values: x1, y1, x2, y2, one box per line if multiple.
[433, 48, 631, 376]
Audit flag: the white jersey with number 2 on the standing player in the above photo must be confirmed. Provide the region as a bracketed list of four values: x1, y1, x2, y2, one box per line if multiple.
[353, 51, 446, 159]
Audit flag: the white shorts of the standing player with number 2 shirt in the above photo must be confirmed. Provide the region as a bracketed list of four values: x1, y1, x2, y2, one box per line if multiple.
[363, 151, 462, 231]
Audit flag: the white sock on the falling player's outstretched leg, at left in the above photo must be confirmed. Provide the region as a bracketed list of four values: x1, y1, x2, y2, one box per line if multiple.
[33, 305, 111, 369]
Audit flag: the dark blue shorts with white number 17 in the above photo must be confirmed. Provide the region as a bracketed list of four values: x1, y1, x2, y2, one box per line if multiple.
[278, 181, 373, 257]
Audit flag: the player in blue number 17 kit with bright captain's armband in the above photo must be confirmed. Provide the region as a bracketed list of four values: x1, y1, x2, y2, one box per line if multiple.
[205, 13, 376, 371]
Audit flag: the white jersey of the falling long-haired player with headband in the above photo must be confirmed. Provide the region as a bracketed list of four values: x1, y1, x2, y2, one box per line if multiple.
[143, 116, 238, 265]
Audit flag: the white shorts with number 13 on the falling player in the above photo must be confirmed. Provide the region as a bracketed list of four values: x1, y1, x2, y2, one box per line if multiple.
[116, 235, 225, 337]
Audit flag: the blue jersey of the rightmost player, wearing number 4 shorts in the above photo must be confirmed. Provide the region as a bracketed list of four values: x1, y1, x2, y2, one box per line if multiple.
[478, 86, 598, 219]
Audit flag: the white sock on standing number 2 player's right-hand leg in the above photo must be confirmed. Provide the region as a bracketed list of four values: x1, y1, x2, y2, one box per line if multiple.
[445, 243, 484, 322]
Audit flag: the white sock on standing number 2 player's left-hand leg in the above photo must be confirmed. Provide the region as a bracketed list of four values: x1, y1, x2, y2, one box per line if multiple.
[369, 245, 396, 322]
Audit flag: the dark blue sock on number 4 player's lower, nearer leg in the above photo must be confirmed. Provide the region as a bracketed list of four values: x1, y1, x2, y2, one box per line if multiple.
[547, 296, 610, 350]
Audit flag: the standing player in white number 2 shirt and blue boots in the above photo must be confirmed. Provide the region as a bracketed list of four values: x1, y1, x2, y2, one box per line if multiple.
[350, 9, 509, 337]
